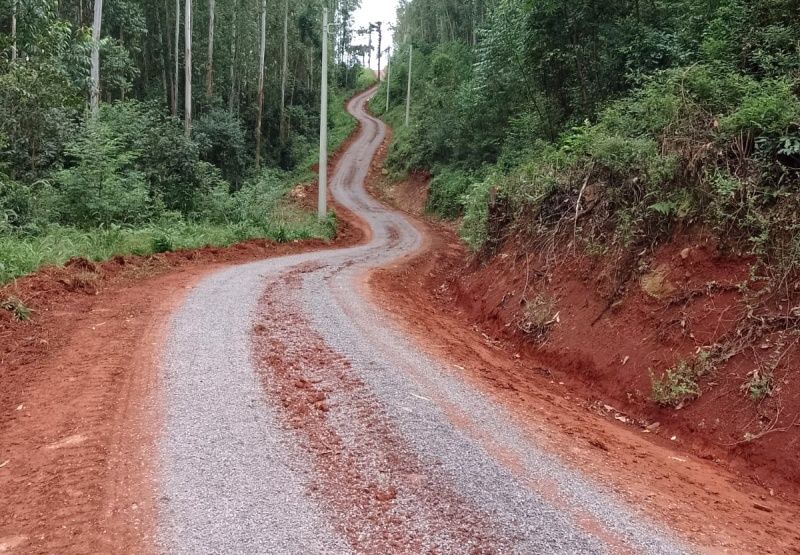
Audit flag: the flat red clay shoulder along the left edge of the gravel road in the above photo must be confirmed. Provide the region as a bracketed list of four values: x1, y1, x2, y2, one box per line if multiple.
[0, 138, 365, 554]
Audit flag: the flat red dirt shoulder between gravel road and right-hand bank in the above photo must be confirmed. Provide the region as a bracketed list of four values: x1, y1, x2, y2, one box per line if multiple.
[367, 135, 800, 553]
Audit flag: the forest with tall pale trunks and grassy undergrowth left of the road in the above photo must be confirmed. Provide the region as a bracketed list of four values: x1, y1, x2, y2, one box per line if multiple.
[0, 0, 373, 282]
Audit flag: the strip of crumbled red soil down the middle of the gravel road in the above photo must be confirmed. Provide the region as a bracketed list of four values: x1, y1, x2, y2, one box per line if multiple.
[253, 267, 500, 553]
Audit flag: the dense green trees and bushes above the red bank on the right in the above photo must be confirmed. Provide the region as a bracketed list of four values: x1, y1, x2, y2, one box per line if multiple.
[373, 0, 800, 286]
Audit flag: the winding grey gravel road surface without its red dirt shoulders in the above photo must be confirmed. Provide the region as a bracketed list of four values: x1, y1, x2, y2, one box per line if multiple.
[156, 89, 690, 554]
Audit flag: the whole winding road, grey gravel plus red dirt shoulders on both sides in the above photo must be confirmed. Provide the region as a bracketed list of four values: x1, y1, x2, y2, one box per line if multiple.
[9, 89, 800, 555]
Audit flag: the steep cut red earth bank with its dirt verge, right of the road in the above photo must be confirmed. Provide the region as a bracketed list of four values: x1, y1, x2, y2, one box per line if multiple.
[367, 132, 800, 553]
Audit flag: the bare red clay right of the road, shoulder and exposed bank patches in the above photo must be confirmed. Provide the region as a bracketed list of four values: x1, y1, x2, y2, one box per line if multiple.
[369, 164, 800, 553]
